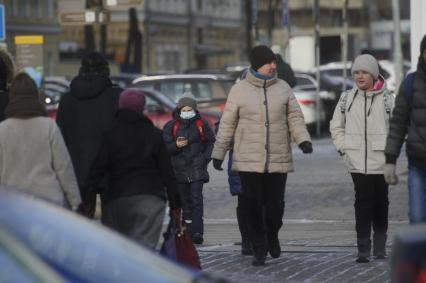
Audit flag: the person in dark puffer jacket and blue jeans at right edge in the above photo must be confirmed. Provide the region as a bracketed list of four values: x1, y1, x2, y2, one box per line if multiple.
[385, 36, 426, 223]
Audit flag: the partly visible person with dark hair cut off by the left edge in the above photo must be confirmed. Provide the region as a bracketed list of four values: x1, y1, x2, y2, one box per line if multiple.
[0, 48, 15, 122]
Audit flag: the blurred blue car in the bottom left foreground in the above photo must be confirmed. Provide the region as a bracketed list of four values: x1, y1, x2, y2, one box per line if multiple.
[0, 188, 225, 283]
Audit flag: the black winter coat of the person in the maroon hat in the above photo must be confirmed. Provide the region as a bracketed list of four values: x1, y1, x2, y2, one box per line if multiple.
[88, 110, 180, 208]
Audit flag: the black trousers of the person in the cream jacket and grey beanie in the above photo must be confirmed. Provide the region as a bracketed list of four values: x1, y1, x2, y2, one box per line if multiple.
[351, 173, 389, 238]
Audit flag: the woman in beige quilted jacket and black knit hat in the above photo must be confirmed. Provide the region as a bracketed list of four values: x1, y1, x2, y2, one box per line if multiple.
[212, 45, 313, 266]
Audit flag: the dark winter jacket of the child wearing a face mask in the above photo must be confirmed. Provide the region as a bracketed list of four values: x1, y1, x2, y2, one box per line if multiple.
[163, 113, 215, 183]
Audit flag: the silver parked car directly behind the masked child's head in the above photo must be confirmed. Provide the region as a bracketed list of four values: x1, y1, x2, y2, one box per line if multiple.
[132, 74, 234, 113]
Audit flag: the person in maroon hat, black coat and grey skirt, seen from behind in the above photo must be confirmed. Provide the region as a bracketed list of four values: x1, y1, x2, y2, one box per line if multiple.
[88, 89, 180, 248]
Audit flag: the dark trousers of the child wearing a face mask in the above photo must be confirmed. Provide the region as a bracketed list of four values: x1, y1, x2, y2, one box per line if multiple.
[178, 181, 204, 236]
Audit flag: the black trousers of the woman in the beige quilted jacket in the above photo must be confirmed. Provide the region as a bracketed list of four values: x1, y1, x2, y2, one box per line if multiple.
[240, 172, 287, 256]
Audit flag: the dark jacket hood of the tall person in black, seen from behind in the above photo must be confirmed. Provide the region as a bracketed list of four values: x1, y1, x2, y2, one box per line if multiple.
[70, 74, 112, 99]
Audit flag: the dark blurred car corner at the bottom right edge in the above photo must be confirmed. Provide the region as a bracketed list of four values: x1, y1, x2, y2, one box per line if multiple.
[391, 224, 426, 283]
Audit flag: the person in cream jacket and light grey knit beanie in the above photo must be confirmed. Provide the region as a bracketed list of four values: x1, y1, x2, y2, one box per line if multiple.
[330, 54, 394, 263]
